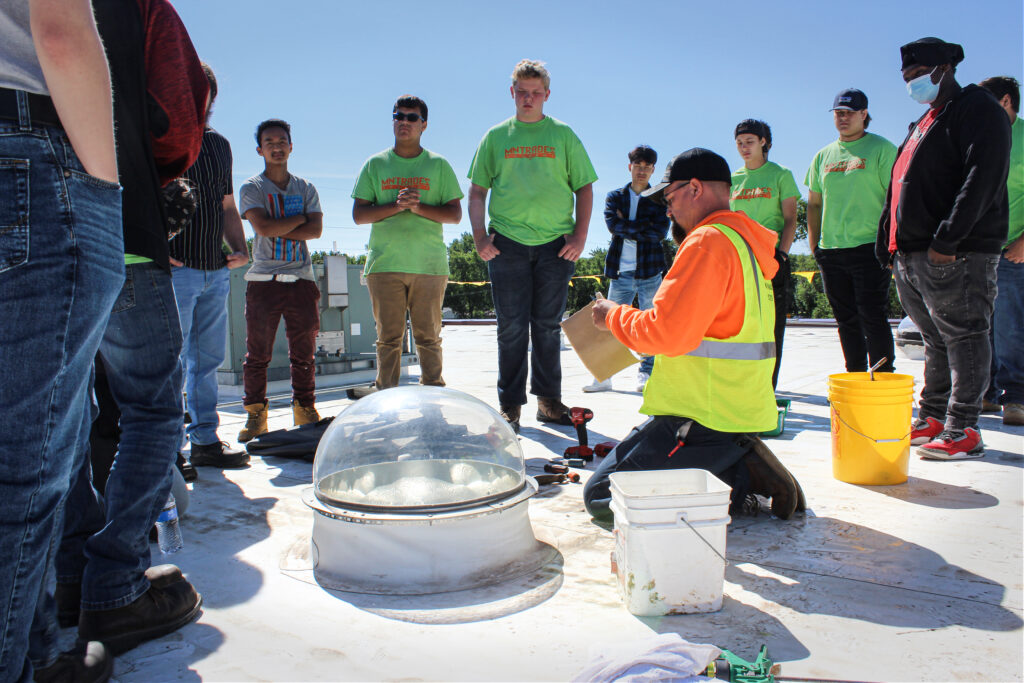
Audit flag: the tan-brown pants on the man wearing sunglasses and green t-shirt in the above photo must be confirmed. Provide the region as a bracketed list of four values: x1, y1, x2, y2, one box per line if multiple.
[367, 272, 447, 389]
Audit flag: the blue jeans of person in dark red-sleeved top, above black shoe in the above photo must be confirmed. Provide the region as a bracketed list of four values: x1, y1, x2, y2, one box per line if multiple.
[58, 263, 182, 609]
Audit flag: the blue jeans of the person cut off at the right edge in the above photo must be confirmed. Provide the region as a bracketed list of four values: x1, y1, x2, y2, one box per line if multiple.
[986, 255, 1024, 405]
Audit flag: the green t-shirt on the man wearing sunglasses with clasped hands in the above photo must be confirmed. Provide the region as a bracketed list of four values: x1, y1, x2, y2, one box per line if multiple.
[352, 148, 462, 275]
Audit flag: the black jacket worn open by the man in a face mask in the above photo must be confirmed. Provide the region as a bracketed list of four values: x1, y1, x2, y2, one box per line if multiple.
[874, 85, 1011, 265]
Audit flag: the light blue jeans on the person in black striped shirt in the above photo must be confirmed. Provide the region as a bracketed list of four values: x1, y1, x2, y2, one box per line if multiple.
[171, 267, 231, 445]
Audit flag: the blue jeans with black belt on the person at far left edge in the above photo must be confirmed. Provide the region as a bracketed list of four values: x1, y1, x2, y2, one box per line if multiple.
[0, 116, 124, 681]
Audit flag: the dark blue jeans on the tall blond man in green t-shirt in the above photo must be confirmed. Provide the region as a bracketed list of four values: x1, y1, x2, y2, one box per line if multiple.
[487, 232, 575, 405]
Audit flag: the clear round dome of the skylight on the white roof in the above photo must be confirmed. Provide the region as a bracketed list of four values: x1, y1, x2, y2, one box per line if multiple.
[313, 386, 526, 512]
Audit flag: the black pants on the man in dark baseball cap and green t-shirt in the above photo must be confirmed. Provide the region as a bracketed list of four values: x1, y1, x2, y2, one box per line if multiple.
[814, 243, 896, 373]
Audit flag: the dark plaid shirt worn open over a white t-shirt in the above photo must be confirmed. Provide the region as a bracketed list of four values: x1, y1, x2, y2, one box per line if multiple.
[604, 185, 669, 280]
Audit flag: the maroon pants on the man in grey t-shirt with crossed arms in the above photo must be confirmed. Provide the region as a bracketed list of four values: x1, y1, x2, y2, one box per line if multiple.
[242, 280, 319, 408]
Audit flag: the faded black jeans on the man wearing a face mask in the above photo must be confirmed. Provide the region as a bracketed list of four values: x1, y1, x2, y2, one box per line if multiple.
[895, 252, 999, 429]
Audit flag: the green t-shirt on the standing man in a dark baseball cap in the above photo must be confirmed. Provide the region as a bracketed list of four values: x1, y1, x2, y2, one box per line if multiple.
[804, 133, 896, 249]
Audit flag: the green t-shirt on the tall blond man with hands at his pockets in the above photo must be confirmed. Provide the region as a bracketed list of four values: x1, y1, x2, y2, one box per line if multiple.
[467, 117, 597, 246]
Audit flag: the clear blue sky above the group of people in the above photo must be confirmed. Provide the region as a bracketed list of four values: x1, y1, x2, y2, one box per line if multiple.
[172, 0, 1024, 254]
